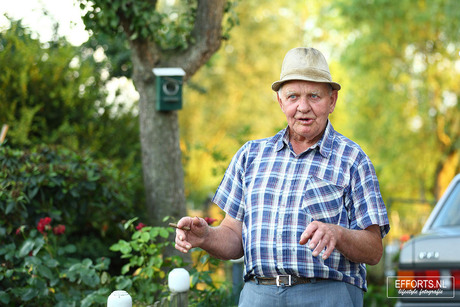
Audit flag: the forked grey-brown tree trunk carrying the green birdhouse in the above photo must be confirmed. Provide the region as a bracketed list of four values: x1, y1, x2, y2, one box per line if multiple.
[125, 0, 226, 225]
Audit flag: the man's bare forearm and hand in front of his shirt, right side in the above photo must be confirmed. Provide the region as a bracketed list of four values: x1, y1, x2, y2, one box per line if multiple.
[299, 221, 383, 265]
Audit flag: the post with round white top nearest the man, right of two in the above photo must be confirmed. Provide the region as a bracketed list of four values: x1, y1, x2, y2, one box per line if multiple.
[168, 268, 190, 307]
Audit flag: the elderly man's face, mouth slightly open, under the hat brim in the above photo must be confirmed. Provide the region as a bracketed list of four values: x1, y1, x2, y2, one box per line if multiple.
[277, 80, 337, 148]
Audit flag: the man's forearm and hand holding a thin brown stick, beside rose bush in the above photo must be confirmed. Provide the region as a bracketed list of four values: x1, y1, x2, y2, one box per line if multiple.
[175, 215, 243, 260]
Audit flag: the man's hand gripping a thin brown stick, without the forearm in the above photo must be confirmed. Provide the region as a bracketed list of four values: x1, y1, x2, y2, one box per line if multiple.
[175, 217, 209, 253]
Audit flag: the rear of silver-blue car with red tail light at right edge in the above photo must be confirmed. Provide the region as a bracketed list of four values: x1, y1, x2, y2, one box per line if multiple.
[394, 174, 460, 307]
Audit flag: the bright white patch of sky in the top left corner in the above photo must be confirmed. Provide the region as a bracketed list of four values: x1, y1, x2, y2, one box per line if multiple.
[0, 0, 88, 46]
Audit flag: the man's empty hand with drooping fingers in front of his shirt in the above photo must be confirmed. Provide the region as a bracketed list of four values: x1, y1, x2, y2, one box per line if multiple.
[299, 221, 341, 259]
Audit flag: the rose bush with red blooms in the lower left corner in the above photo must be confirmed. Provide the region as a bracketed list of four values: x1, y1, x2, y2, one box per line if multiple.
[0, 145, 237, 306]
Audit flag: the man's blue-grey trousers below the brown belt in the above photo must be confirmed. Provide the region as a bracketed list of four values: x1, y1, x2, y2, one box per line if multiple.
[238, 280, 364, 307]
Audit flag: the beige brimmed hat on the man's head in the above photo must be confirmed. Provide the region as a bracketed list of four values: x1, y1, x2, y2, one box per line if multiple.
[272, 47, 341, 92]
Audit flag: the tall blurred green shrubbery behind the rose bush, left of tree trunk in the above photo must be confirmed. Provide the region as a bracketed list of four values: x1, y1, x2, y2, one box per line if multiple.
[0, 20, 144, 203]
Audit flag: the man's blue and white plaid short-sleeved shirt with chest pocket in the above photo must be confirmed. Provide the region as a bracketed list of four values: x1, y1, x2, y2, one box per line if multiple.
[213, 122, 390, 290]
